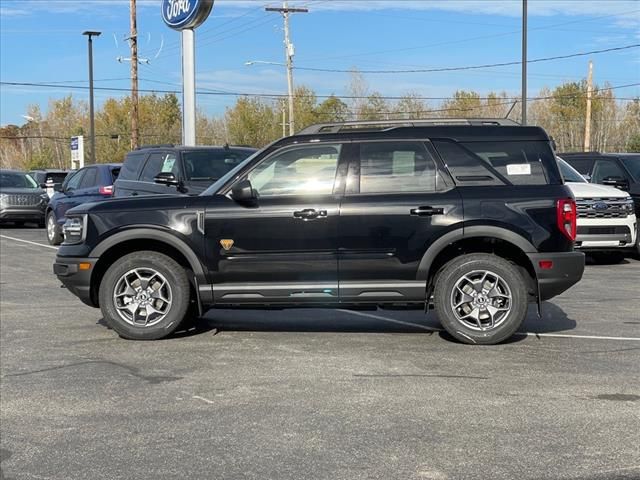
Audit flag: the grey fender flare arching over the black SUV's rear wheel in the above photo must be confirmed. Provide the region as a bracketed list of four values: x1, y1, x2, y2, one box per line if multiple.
[417, 225, 538, 280]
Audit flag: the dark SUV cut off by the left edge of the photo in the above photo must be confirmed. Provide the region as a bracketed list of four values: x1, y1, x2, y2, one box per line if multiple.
[0, 170, 49, 227]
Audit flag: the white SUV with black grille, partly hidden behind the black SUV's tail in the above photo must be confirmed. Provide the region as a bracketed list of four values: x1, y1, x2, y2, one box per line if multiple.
[558, 157, 638, 263]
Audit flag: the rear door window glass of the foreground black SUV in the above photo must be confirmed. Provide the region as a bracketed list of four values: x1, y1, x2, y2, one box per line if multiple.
[360, 142, 436, 193]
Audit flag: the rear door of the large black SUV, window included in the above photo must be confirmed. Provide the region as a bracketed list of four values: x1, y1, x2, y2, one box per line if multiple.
[338, 140, 462, 303]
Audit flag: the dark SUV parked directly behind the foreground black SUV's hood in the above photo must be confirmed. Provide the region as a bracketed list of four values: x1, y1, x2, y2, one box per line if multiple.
[114, 145, 256, 197]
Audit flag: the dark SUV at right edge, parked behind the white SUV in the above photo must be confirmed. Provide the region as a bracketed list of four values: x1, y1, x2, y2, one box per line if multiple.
[558, 152, 640, 255]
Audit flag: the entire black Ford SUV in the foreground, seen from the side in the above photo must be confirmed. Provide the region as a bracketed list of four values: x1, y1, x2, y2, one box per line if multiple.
[54, 120, 584, 344]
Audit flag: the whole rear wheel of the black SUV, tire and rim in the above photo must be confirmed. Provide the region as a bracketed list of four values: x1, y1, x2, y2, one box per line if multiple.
[434, 253, 529, 345]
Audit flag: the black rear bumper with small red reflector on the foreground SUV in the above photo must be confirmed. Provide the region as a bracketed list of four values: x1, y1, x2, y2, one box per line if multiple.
[527, 252, 584, 300]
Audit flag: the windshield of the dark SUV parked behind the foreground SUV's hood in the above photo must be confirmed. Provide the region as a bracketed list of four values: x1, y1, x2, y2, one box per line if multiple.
[182, 148, 253, 181]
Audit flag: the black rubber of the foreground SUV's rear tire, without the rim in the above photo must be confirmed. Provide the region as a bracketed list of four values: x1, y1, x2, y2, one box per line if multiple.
[434, 254, 529, 345]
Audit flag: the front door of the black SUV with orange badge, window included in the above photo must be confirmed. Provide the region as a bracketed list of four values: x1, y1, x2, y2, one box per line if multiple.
[205, 144, 342, 304]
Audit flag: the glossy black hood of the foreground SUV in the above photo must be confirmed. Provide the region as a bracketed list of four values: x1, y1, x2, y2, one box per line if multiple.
[67, 195, 194, 214]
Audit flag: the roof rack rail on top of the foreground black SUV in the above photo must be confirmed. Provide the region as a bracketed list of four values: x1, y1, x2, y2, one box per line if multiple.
[296, 118, 520, 135]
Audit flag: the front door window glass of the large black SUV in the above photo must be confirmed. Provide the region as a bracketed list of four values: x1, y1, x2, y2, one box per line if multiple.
[248, 145, 341, 197]
